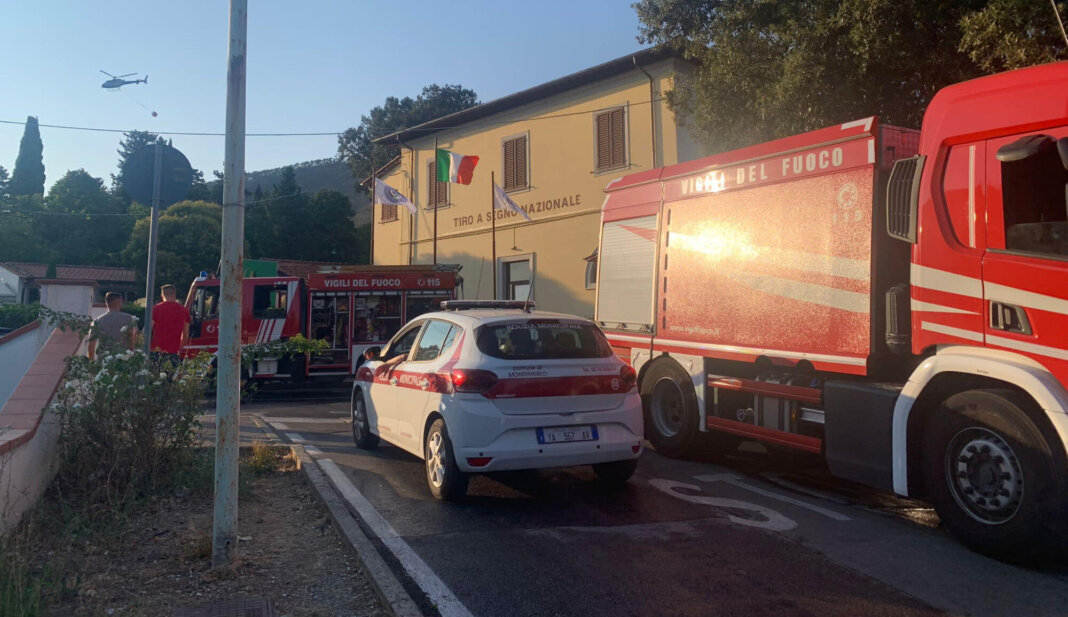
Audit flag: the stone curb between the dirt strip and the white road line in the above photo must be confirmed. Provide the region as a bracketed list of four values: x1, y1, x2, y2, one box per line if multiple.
[249, 414, 423, 617]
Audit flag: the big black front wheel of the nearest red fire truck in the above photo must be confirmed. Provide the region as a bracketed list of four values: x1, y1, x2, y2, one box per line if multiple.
[924, 390, 1068, 564]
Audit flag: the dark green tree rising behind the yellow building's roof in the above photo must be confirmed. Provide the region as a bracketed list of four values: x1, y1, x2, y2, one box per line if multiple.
[337, 83, 478, 184]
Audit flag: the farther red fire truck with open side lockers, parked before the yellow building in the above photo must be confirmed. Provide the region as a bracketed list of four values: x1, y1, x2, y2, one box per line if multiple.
[184, 265, 460, 382]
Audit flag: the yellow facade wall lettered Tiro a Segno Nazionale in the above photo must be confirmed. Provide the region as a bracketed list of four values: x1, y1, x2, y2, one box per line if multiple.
[373, 60, 700, 317]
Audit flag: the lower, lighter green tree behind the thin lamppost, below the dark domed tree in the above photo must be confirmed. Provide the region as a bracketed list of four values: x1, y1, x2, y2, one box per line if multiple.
[122, 201, 222, 297]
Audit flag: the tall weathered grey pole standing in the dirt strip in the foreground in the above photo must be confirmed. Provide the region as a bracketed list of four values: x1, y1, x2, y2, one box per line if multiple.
[211, 0, 248, 568]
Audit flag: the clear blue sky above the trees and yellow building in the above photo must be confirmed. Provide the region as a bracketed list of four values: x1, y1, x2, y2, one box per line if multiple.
[0, 0, 642, 191]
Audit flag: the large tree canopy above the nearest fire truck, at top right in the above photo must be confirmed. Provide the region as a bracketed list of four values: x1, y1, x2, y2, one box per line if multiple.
[634, 0, 1068, 152]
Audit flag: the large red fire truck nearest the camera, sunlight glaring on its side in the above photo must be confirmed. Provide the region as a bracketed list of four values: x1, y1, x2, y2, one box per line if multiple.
[596, 63, 1068, 559]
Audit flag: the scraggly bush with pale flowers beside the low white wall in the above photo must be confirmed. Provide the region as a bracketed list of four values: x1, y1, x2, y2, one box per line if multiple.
[53, 351, 208, 514]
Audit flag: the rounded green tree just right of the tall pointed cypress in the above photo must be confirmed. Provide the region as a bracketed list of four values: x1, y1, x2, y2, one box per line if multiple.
[34, 170, 134, 266]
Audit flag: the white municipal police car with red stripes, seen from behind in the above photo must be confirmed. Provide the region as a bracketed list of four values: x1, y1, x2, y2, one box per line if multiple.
[351, 301, 642, 500]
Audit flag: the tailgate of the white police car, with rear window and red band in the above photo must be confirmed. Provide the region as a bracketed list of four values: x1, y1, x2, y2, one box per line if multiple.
[476, 319, 629, 415]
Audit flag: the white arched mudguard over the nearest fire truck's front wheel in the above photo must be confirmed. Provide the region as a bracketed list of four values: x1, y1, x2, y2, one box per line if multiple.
[893, 346, 1068, 496]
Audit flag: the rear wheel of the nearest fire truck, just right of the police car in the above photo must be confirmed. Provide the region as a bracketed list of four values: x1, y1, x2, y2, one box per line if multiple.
[642, 360, 700, 457]
